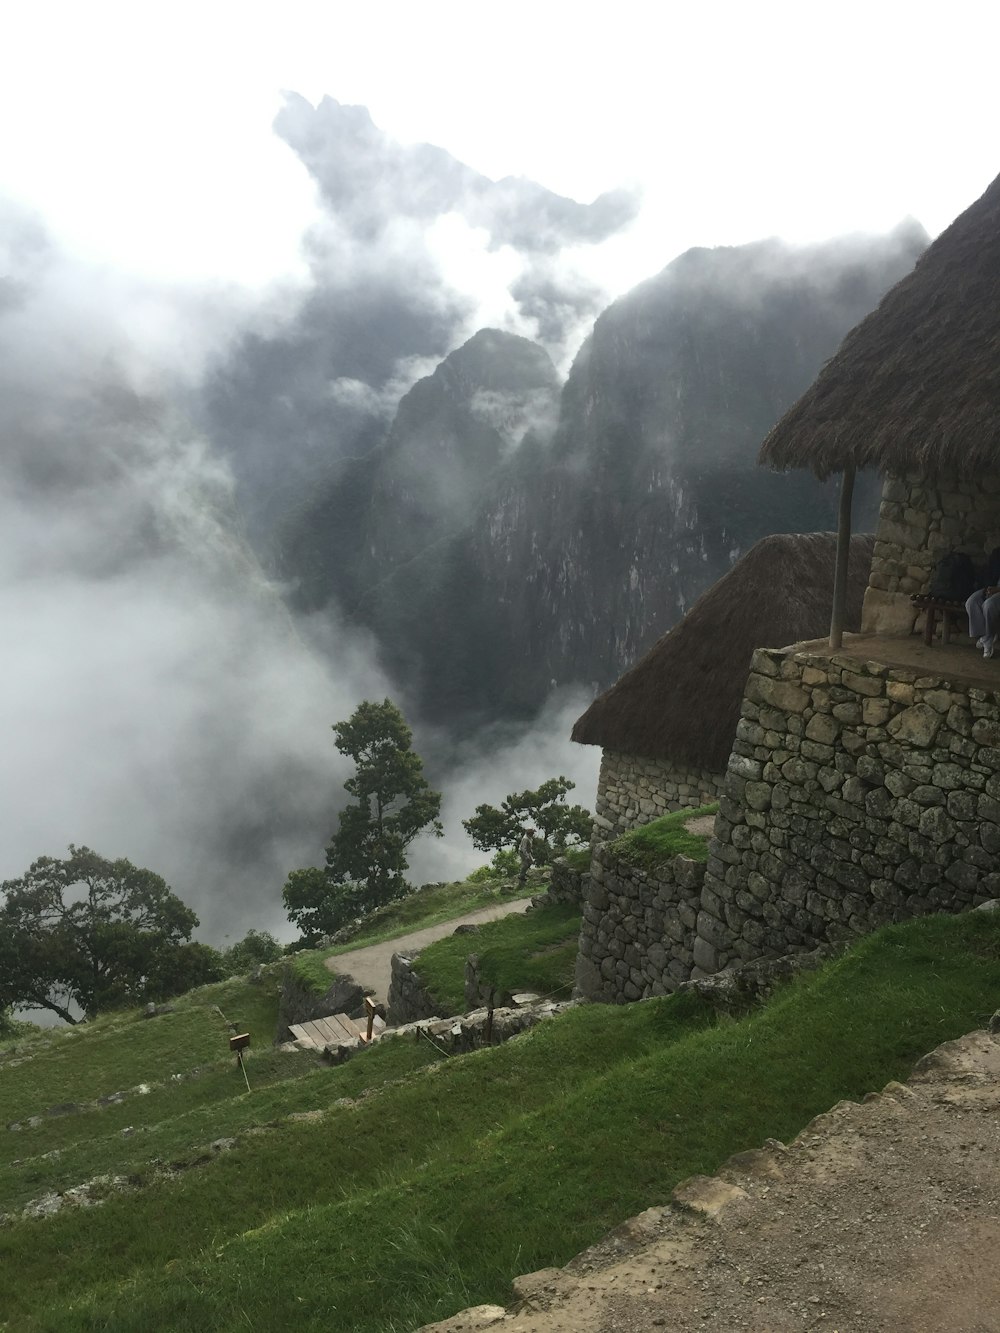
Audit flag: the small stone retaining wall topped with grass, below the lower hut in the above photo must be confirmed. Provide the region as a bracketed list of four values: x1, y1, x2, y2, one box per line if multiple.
[575, 842, 705, 1004]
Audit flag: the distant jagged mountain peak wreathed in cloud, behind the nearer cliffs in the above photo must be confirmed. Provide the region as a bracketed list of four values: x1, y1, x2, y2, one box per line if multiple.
[203, 93, 637, 544]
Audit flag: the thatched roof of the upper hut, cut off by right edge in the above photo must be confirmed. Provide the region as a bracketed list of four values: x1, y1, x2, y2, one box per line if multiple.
[760, 169, 1000, 477]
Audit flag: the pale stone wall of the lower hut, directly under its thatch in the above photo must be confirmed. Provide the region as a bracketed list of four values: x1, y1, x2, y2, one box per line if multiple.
[593, 749, 724, 841]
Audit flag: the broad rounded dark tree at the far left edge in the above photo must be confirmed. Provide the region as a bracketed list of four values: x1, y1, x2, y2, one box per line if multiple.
[0, 845, 205, 1022]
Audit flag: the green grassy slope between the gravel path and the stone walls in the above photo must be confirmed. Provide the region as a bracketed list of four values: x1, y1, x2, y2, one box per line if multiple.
[0, 913, 1000, 1333]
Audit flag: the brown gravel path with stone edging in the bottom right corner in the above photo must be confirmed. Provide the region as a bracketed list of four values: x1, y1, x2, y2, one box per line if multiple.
[428, 1032, 1000, 1333]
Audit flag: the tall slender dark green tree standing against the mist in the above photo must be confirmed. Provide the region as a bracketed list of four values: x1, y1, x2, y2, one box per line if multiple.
[283, 698, 444, 938]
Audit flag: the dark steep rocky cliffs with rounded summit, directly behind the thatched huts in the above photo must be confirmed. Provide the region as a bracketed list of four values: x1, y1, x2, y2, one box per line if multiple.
[280, 228, 925, 722]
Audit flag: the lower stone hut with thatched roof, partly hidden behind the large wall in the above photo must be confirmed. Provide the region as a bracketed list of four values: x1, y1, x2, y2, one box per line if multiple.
[572, 532, 873, 841]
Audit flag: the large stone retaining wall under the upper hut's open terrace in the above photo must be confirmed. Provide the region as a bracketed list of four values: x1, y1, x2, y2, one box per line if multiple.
[697, 649, 1000, 972]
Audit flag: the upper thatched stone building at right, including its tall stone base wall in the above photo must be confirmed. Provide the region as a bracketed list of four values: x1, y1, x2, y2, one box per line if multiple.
[697, 171, 1000, 970]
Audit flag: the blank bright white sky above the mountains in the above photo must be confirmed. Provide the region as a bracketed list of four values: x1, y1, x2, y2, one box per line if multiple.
[7, 0, 1000, 301]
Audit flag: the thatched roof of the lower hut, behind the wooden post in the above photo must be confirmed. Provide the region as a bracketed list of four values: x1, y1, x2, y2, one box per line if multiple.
[573, 532, 875, 773]
